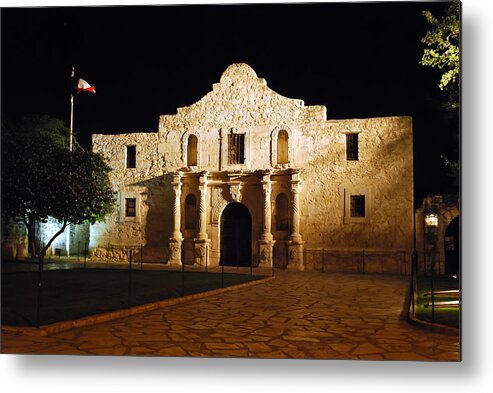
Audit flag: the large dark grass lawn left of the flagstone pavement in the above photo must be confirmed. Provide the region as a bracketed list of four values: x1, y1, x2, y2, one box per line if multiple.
[2, 269, 261, 326]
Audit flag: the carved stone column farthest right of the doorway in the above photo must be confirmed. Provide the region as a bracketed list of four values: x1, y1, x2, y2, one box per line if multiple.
[287, 169, 305, 270]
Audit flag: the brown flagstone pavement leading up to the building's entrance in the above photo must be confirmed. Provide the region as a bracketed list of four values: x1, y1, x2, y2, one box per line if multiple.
[2, 271, 460, 361]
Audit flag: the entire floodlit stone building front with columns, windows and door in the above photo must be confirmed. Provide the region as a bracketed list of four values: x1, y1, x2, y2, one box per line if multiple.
[90, 64, 413, 274]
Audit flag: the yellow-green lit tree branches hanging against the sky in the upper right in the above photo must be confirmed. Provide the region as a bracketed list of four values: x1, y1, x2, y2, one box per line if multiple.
[420, 1, 460, 108]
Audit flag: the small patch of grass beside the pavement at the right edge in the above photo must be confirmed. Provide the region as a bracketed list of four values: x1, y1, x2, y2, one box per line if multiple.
[415, 276, 460, 327]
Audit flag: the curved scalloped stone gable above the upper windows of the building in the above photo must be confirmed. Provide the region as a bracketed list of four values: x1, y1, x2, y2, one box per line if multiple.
[159, 63, 326, 131]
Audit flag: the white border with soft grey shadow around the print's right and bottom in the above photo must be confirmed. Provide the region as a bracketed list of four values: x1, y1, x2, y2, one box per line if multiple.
[0, 0, 493, 393]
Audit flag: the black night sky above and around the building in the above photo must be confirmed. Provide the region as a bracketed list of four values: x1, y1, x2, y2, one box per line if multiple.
[1, 2, 459, 204]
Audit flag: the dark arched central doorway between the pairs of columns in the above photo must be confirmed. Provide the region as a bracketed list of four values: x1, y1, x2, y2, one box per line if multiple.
[219, 202, 252, 266]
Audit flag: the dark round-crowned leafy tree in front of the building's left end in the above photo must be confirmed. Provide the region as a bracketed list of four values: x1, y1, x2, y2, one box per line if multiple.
[2, 116, 114, 262]
